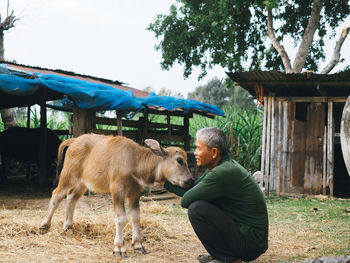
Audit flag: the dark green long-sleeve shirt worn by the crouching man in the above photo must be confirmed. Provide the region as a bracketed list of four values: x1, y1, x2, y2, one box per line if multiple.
[164, 155, 268, 253]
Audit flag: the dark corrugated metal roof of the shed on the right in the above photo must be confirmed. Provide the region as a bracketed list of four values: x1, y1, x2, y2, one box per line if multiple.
[227, 70, 350, 97]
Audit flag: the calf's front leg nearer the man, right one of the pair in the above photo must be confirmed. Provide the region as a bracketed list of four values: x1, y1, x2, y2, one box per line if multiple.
[129, 195, 147, 254]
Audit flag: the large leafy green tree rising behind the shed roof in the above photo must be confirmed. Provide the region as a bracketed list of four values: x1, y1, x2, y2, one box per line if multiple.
[148, 0, 350, 78]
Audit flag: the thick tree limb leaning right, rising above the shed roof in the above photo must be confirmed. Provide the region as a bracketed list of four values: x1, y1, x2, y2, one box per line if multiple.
[293, 0, 323, 73]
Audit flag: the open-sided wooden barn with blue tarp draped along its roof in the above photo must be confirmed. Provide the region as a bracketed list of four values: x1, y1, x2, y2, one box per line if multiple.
[0, 62, 224, 184]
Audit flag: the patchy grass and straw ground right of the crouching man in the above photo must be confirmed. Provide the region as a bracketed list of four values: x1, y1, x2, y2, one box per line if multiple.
[266, 196, 350, 261]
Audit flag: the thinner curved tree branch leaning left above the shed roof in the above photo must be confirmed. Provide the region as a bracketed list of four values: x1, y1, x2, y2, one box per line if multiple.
[267, 8, 292, 73]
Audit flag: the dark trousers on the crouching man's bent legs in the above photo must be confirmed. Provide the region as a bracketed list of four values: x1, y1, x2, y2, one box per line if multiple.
[188, 200, 258, 262]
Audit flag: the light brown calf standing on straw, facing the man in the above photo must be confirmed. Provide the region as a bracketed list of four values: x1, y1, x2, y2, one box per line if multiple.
[40, 134, 192, 257]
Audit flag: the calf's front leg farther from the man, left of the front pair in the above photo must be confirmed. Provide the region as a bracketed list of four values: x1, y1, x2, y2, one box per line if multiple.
[111, 190, 127, 258]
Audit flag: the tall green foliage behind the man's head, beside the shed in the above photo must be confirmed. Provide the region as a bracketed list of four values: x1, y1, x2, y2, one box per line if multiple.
[190, 107, 263, 172]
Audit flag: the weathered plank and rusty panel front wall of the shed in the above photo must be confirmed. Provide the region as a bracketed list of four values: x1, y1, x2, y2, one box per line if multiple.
[261, 96, 346, 195]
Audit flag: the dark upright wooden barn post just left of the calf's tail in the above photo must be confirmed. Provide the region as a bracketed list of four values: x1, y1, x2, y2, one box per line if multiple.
[39, 89, 48, 185]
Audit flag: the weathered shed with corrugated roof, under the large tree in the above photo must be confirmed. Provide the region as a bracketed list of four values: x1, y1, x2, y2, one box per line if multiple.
[227, 70, 350, 196]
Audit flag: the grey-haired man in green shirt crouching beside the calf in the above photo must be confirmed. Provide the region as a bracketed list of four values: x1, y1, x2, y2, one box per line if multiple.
[164, 127, 268, 263]
